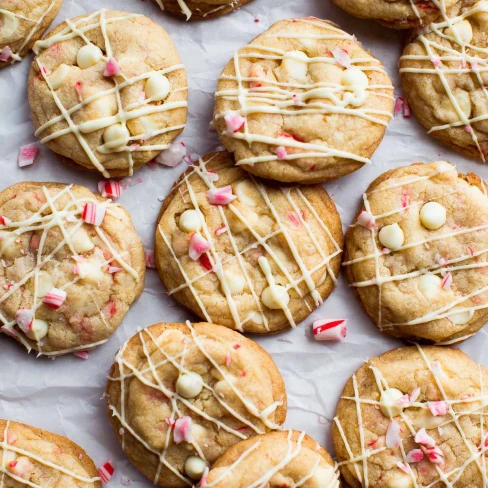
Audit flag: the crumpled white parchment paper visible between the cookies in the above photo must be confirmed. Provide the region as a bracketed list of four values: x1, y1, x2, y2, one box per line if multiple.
[0, 0, 488, 487]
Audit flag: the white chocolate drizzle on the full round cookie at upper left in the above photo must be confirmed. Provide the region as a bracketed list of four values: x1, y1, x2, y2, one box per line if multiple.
[30, 9, 188, 178]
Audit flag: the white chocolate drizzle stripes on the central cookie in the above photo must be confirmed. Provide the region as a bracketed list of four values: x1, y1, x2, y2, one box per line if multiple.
[158, 158, 342, 332]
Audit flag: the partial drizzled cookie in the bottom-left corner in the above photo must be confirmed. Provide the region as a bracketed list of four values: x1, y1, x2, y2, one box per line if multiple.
[0, 420, 102, 488]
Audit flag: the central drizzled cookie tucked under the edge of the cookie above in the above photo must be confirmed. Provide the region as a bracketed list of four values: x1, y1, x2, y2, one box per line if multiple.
[155, 152, 342, 334]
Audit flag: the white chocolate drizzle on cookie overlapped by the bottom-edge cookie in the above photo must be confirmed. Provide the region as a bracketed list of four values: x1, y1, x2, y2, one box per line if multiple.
[109, 321, 283, 486]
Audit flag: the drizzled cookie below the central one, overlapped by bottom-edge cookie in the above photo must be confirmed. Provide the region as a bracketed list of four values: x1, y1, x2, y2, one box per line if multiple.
[106, 322, 286, 488]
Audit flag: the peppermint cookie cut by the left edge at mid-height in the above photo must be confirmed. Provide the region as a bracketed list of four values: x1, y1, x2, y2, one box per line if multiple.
[0, 182, 145, 356]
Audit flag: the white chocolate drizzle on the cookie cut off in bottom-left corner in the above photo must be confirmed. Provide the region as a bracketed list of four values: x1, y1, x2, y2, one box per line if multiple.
[0, 421, 100, 488]
